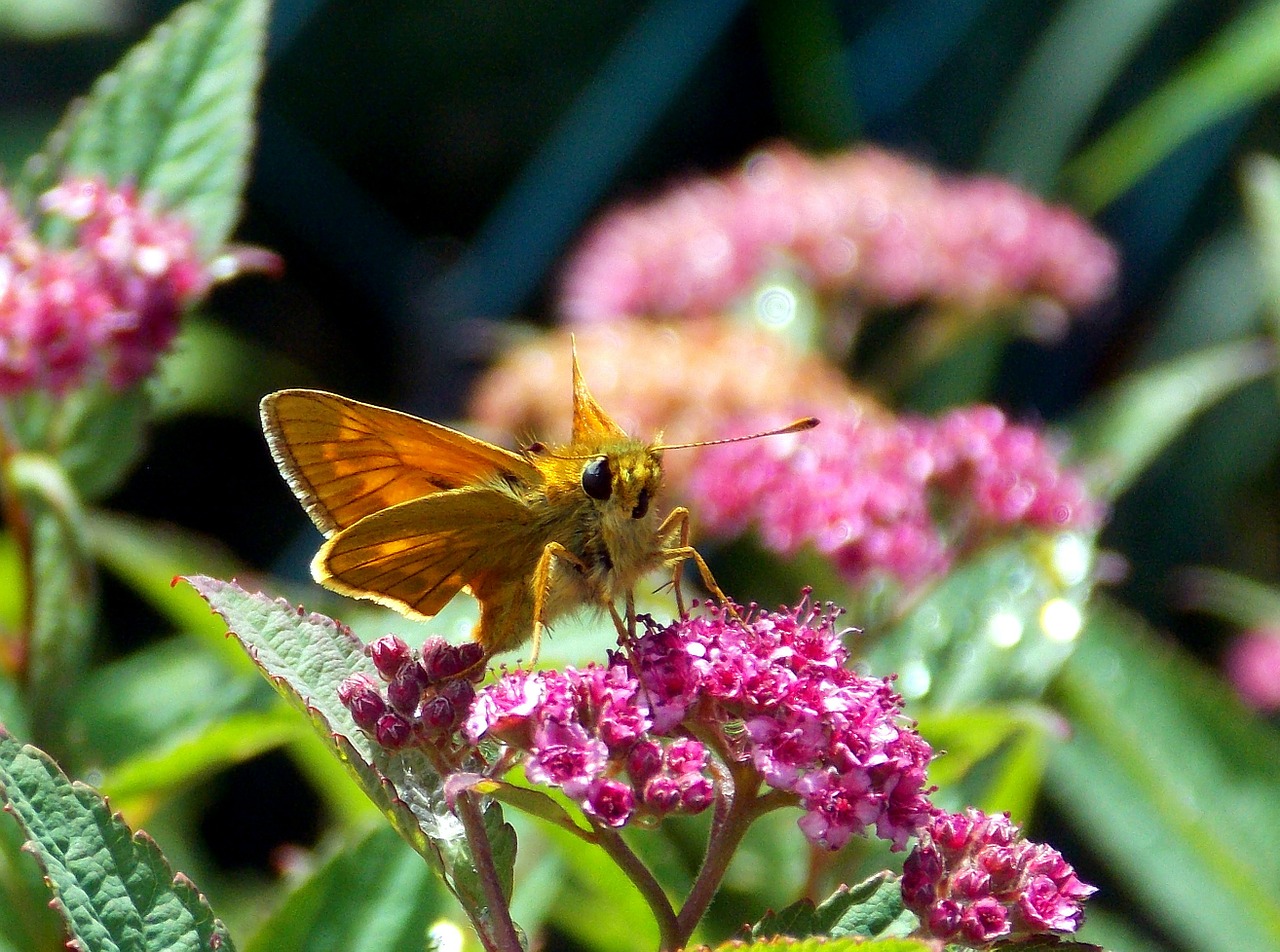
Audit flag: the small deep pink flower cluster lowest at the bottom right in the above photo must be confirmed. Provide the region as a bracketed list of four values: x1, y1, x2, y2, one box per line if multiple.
[902, 807, 1097, 946]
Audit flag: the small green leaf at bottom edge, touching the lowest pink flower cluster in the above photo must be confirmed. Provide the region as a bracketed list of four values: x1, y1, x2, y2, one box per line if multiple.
[750, 873, 918, 939]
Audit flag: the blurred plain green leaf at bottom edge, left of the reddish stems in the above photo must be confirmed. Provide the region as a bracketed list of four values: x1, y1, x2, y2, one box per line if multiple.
[244, 825, 447, 952]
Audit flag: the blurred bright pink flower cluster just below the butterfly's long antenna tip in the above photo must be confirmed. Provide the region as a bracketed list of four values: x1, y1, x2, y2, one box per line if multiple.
[689, 406, 1102, 583]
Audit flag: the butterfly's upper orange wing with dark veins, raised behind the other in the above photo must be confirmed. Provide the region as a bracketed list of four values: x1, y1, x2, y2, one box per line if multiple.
[261, 390, 541, 536]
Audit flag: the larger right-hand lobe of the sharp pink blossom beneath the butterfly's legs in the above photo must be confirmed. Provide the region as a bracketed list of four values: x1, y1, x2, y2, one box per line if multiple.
[634, 604, 933, 850]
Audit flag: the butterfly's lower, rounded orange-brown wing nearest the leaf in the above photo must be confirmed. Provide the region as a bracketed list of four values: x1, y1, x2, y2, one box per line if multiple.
[311, 486, 545, 621]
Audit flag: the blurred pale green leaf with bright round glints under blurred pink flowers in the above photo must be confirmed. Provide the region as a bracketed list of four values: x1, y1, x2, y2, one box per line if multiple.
[855, 532, 1093, 711]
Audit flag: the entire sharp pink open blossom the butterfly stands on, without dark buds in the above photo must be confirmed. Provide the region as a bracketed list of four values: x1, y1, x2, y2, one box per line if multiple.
[462, 593, 932, 850]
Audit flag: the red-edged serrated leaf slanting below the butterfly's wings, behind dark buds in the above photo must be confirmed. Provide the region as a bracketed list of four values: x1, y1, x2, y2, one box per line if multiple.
[187, 576, 512, 921]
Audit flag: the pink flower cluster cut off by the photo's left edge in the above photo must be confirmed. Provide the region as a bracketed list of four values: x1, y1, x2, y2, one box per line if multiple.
[0, 179, 212, 395]
